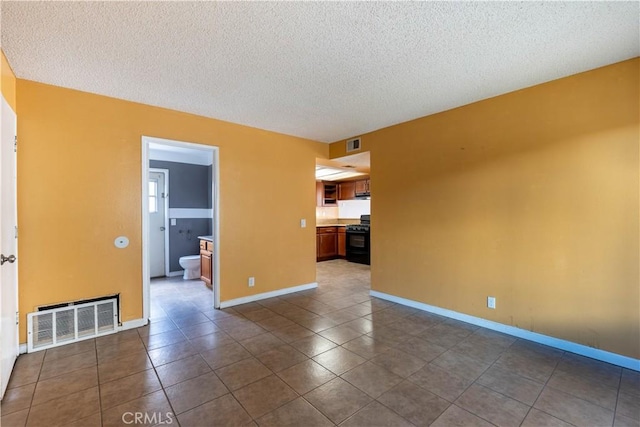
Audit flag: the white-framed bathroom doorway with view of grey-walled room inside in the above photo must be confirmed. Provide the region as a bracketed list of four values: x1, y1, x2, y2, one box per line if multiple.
[142, 136, 220, 319]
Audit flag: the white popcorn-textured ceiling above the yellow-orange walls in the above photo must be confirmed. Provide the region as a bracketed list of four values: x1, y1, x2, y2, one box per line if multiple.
[1, 1, 640, 142]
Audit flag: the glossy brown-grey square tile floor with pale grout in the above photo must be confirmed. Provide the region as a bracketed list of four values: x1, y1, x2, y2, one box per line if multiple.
[2, 260, 640, 427]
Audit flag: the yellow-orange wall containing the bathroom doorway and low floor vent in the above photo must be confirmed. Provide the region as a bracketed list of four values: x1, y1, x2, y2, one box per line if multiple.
[17, 79, 329, 342]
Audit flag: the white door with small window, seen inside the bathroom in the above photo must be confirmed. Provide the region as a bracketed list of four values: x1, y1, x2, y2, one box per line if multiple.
[149, 172, 167, 277]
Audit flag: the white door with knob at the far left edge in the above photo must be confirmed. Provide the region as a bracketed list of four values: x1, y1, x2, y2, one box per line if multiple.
[0, 97, 18, 398]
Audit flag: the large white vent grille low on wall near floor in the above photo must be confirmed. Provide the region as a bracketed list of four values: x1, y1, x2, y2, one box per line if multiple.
[27, 298, 118, 353]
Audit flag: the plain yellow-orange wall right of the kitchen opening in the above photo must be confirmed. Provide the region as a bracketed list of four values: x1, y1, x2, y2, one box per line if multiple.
[331, 58, 640, 358]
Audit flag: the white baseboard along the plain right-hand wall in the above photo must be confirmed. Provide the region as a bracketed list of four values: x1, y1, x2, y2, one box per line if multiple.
[370, 291, 640, 371]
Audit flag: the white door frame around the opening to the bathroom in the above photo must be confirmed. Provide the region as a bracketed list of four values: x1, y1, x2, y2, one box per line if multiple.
[141, 135, 220, 322]
